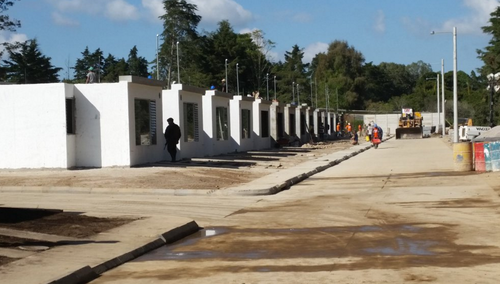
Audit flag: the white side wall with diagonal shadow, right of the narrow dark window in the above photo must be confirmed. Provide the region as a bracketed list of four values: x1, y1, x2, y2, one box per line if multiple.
[75, 82, 131, 167]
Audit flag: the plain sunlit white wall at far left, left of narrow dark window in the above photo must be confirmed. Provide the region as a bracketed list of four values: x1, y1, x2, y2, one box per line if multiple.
[0, 83, 72, 169]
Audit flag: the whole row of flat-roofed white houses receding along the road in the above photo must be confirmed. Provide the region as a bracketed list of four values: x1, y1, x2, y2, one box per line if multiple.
[0, 76, 336, 169]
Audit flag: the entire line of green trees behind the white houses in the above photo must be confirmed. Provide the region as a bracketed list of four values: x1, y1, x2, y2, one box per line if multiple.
[0, 0, 500, 125]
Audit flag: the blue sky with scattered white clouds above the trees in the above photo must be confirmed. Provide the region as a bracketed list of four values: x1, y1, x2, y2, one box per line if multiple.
[0, 0, 499, 79]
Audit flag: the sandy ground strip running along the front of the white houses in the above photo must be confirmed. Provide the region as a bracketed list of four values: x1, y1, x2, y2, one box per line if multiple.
[0, 141, 352, 190]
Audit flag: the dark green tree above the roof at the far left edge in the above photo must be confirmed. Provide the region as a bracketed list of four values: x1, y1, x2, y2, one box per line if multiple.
[3, 39, 62, 84]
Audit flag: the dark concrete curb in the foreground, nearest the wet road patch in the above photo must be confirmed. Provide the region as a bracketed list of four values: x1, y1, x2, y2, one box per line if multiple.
[49, 221, 201, 284]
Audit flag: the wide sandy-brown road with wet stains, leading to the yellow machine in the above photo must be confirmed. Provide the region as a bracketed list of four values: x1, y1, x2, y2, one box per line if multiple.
[86, 138, 500, 284]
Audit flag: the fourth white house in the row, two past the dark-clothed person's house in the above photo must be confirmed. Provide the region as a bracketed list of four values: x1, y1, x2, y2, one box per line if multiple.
[226, 96, 256, 152]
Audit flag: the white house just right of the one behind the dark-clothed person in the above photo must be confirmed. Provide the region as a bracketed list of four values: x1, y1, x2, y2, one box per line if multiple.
[202, 90, 234, 156]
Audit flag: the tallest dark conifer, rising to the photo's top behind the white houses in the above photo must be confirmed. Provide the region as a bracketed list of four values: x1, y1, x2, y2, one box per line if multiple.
[159, 0, 201, 86]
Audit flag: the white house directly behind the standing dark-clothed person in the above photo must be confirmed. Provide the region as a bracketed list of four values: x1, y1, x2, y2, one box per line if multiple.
[162, 84, 205, 160]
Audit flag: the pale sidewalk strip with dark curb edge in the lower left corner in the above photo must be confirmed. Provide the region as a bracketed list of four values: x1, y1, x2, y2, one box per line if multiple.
[0, 216, 199, 284]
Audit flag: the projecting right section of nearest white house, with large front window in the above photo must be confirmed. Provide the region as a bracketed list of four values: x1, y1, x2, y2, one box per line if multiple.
[75, 76, 163, 167]
